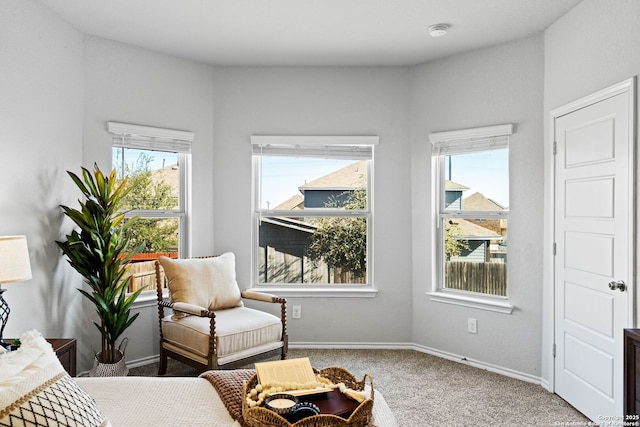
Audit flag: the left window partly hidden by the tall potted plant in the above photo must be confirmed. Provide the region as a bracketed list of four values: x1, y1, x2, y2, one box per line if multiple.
[108, 122, 193, 292]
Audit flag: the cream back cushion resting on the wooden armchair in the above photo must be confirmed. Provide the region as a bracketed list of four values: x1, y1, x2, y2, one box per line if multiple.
[158, 252, 242, 310]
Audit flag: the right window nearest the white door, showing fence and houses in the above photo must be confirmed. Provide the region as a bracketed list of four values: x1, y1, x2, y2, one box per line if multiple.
[430, 125, 512, 310]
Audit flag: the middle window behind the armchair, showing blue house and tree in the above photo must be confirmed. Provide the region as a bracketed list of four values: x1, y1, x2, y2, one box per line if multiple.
[251, 136, 378, 289]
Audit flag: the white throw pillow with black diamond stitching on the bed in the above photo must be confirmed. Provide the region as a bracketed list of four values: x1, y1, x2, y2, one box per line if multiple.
[0, 331, 111, 427]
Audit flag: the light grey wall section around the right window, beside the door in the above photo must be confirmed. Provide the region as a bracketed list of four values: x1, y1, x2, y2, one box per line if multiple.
[411, 35, 544, 378]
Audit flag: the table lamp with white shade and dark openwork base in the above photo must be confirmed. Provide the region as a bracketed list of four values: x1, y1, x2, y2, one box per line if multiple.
[0, 236, 31, 348]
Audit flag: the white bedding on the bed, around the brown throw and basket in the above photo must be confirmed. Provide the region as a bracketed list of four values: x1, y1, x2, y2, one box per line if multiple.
[76, 377, 398, 427]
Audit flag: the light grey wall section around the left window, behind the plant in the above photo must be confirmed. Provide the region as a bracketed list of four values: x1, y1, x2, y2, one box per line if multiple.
[81, 36, 214, 369]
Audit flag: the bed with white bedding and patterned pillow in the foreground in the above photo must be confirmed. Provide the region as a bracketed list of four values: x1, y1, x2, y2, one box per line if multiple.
[0, 331, 397, 427]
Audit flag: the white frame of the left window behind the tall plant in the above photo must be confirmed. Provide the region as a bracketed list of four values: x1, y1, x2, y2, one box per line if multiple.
[107, 122, 194, 300]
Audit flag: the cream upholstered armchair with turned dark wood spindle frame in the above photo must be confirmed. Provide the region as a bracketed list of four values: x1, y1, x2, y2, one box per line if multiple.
[156, 252, 288, 375]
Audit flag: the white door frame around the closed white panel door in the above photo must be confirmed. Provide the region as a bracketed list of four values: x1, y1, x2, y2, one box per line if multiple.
[541, 76, 640, 393]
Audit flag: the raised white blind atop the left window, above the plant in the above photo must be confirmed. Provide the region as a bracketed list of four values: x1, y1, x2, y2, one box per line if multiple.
[107, 122, 194, 153]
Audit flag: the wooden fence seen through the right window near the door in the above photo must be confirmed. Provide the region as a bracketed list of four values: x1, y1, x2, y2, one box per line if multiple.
[444, 261, 507, 296]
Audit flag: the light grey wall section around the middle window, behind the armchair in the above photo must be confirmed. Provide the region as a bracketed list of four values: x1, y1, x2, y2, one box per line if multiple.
[213, 67, 411, 343]
